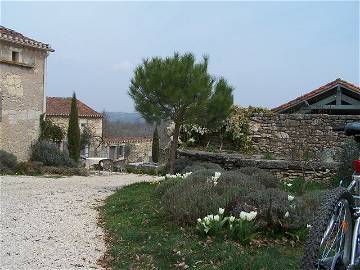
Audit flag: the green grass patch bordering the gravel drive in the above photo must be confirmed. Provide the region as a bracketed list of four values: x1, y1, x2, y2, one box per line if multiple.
[102, 183, 303, 270]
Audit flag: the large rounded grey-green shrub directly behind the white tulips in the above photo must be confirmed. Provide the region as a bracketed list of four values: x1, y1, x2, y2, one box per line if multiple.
[159, 170, 264, 224]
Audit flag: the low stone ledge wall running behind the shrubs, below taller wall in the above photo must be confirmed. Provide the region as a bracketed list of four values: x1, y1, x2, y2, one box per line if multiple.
[178, 149, 339, 182]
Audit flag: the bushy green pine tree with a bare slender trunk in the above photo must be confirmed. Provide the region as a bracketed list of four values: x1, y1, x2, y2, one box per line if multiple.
[129, 53, 233, 173]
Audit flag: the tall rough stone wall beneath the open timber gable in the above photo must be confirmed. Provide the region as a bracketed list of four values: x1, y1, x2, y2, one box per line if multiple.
[250, 114, 360, 161]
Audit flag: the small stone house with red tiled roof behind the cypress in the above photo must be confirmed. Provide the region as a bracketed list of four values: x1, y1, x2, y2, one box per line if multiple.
[46, 97, 103, 157]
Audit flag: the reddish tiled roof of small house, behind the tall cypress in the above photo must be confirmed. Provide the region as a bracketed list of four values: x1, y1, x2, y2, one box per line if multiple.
[46, 97, 103, 118]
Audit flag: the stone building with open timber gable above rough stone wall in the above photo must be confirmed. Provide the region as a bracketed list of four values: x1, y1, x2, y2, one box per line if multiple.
[250, 79, 360, 161]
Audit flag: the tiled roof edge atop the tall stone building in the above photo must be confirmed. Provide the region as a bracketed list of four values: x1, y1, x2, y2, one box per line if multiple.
[0, 25, 54, 52]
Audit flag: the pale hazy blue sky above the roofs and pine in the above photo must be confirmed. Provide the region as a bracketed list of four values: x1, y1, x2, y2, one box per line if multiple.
[0, 0, 360, 112]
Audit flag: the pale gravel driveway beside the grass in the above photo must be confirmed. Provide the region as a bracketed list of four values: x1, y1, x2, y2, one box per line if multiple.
[0, 174, 158, 269]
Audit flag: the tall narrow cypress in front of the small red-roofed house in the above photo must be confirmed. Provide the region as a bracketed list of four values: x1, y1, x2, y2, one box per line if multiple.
[67, 92, 80, 162]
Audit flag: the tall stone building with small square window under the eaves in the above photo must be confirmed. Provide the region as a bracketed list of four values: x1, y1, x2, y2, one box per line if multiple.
[0, 26, 54, 160]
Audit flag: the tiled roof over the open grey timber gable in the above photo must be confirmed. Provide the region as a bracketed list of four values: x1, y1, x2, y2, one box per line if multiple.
[271, 79, 360, 113]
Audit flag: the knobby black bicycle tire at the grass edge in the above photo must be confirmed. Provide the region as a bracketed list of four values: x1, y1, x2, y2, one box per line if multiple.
[301, 188, 353, 270]
